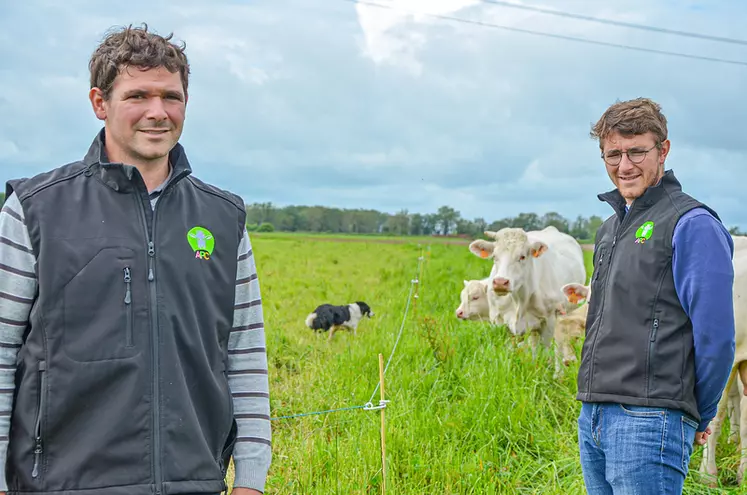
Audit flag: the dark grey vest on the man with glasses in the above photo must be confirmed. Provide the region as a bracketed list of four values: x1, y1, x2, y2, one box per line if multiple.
[577, 171, 719, 421]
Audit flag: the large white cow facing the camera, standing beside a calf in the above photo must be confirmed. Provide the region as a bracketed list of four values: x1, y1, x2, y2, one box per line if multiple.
[469, 226, 586, 358]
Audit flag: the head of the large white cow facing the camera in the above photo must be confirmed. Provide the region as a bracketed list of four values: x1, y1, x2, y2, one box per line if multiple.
[469, 227, 548, 294]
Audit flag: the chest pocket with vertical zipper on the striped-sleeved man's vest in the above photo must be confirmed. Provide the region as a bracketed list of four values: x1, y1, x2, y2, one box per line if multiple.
[62, 247, 144, 362]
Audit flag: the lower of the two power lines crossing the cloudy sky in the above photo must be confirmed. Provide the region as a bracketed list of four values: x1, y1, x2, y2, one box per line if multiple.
[344, 0, 747, 66]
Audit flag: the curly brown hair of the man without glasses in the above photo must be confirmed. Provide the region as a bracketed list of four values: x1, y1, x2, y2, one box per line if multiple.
[88, 23, 189, 100]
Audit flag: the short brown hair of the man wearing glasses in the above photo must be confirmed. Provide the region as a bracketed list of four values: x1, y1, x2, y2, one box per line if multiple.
[590, 98, 667, 149]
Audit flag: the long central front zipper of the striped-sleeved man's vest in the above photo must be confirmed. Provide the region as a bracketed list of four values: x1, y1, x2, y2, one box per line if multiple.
[135, 191, 165, 495]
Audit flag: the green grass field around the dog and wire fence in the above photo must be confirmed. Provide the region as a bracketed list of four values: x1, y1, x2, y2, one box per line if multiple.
[229, 234, 747, 495]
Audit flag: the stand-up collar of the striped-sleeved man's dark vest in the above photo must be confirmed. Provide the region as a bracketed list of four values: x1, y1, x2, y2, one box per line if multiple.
[83, 128, 192, 192]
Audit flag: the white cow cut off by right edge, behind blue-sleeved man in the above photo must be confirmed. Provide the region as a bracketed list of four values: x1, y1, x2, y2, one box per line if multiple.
[700, 236, 747, 485]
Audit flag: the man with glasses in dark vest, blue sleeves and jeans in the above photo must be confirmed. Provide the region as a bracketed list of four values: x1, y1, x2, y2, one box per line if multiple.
[577, 98, 735, 495]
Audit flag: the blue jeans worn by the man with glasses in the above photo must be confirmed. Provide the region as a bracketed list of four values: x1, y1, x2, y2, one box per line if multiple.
[578, 403, 698, 495]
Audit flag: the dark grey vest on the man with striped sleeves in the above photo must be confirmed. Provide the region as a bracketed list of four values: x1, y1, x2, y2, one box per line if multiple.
[6, 133, 245, 495]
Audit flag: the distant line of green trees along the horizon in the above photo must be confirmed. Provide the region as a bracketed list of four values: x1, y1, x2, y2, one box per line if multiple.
[0, 192, 747, 241]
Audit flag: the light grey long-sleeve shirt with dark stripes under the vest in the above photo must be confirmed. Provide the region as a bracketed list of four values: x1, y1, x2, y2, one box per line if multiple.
[0, 194, 271, 491]
